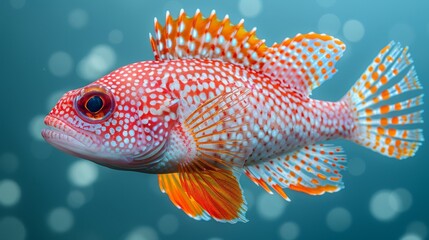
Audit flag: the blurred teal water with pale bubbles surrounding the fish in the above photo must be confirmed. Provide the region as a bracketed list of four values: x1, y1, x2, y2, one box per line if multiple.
[0, 0, 429, 240]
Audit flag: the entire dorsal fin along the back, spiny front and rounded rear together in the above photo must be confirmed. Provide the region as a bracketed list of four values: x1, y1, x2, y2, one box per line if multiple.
[150, 10, 345, 95]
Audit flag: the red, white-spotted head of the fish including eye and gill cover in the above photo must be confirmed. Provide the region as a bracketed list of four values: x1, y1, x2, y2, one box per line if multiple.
[42, 63, 177, 171]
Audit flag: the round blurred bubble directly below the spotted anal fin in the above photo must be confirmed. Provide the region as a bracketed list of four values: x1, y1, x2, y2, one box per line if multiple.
[256, 193, 286, 220]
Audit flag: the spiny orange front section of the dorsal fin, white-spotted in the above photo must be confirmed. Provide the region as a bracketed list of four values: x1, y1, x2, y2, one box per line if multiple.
[150, 9, 267, 69]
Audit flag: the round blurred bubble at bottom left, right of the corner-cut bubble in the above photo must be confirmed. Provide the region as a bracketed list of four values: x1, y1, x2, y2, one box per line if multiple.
[48, 207, 74, 233]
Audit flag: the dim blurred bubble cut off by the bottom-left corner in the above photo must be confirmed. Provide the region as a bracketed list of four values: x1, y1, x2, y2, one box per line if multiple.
[0, 217, 27, 240]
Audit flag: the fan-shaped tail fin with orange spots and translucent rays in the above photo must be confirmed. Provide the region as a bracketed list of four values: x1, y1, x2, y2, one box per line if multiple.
[343, 42, 423, 159]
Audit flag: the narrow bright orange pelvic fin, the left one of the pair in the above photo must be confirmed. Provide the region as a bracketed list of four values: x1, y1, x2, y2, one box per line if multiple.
[158, 173, 210, 220]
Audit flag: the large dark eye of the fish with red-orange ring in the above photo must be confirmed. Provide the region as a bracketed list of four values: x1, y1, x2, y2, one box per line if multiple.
[75, 85, 115, 122]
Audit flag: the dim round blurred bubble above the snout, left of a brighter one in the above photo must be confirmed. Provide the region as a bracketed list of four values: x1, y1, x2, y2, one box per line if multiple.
[48, 51, 73, 77]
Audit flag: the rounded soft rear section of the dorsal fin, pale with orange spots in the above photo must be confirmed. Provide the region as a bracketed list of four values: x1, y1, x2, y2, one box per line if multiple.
[261, 33, 346, 95]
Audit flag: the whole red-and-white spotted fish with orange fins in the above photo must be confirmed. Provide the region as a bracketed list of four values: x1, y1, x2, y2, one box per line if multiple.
[42, 10, 424, 223]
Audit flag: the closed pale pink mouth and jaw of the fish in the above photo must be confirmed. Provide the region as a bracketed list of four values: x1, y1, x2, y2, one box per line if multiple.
[42, 115, 101, 159]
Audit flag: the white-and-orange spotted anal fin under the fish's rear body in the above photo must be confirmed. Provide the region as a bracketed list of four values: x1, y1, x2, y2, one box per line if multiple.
[245, 144, 346, 200]
